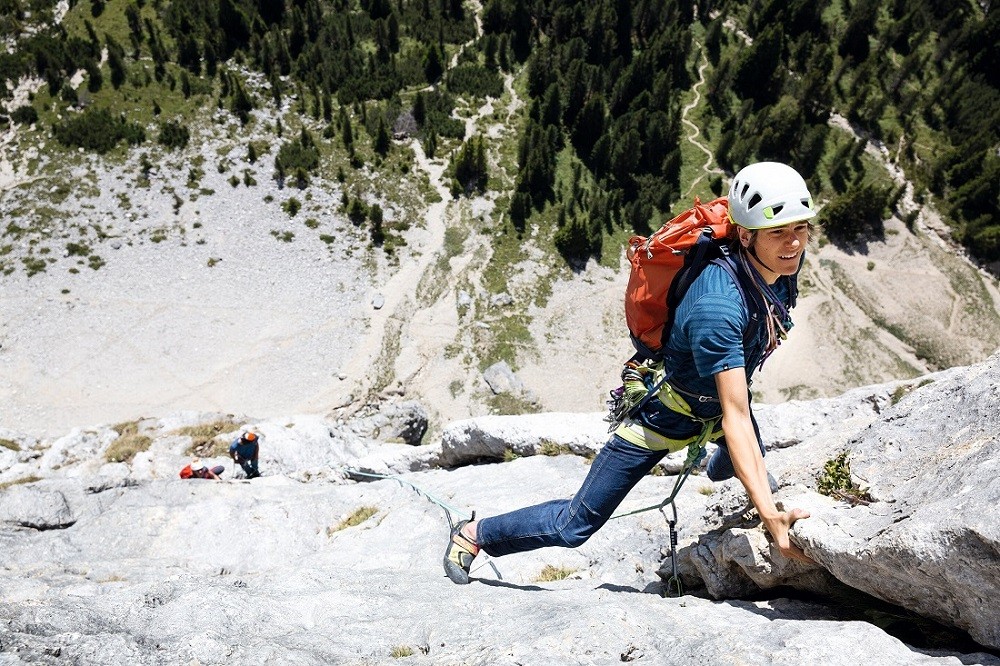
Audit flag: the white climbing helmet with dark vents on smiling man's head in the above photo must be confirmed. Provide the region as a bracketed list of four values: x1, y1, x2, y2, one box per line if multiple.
[729, 162, 816, 230]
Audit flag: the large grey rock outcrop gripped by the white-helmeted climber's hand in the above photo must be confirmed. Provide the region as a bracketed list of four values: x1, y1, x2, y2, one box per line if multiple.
[664, 355, 1000, 648]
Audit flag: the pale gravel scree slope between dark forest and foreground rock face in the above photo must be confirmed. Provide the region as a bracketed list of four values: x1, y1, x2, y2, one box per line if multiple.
[0, 67, 1000, 436]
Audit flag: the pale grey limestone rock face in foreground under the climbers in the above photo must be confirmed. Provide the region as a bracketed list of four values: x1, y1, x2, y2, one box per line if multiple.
[0, 356, 1000, 665]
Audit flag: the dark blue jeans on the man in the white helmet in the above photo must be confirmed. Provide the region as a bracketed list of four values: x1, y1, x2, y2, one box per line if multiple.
[476, 435, 764, 557]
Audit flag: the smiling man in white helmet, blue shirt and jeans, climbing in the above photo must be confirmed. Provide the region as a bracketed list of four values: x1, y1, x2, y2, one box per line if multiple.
[444, 162, 816, 584]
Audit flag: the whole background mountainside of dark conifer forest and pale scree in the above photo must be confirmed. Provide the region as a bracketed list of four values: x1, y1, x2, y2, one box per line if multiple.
[0, 0, 1000, 435]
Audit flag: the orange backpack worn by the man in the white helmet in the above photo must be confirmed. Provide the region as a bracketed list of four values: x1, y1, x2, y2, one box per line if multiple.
[625, 197, 740, 360]
